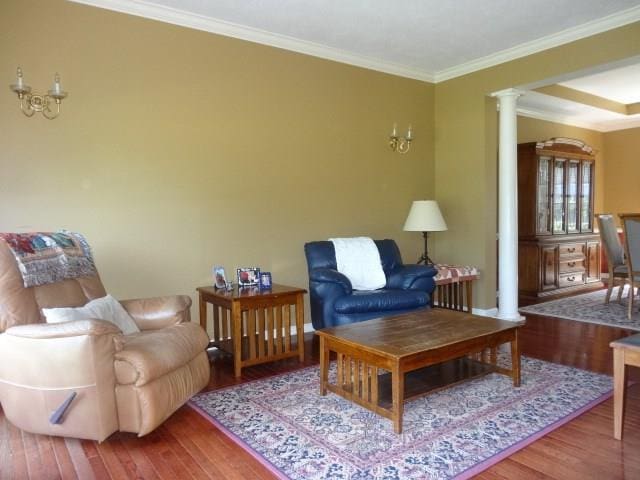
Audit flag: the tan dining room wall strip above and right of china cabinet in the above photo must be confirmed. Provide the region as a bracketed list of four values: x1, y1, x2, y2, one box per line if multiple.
[518, 116, 609, 213]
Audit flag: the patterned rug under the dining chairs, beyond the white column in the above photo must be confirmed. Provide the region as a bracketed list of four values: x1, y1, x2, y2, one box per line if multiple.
[519, 286, 640, 331]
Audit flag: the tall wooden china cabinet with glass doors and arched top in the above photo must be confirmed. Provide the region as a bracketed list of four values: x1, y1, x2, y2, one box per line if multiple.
[518, 138, 600, 300]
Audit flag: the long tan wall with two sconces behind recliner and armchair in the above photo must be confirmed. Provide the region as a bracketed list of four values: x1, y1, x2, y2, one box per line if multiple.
[0, 0, 434, 321]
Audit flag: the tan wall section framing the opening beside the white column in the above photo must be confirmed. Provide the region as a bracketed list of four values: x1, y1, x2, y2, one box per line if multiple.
[434, 22, 640, 308]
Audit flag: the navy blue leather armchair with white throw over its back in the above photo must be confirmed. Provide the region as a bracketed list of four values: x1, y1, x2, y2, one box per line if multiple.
[304, 240, 437, 330]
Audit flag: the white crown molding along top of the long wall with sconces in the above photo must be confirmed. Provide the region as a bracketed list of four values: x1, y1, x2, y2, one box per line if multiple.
[70, 0, 434, 83]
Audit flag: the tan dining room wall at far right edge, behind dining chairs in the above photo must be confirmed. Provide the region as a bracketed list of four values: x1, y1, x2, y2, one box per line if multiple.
[604, 128, 640, 215]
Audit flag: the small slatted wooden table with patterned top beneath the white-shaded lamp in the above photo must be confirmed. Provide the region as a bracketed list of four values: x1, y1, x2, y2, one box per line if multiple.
[431, 264, 480, 313]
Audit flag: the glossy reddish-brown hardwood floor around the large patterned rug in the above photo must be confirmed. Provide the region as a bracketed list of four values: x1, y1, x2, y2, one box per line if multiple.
[0, 315, 640, 480]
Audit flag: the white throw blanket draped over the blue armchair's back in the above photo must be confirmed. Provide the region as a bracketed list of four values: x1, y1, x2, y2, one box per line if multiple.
[329, 237, 387, 290]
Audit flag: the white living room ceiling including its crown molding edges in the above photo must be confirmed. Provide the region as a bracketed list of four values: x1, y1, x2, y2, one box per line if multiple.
[72, 0, 640, 82]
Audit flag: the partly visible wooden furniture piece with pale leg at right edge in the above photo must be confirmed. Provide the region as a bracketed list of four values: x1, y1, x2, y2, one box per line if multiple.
[610, 334, 640, 440]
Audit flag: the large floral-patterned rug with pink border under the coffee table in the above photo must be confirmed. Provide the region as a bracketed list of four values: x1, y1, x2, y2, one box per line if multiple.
[190, 357, 612, 480]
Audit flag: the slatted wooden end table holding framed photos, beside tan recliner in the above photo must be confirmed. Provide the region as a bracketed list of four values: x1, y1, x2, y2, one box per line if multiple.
[197, 284, 307, 377]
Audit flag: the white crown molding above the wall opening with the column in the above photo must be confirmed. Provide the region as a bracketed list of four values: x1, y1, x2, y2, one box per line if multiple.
[434, 6, 640, 83]
